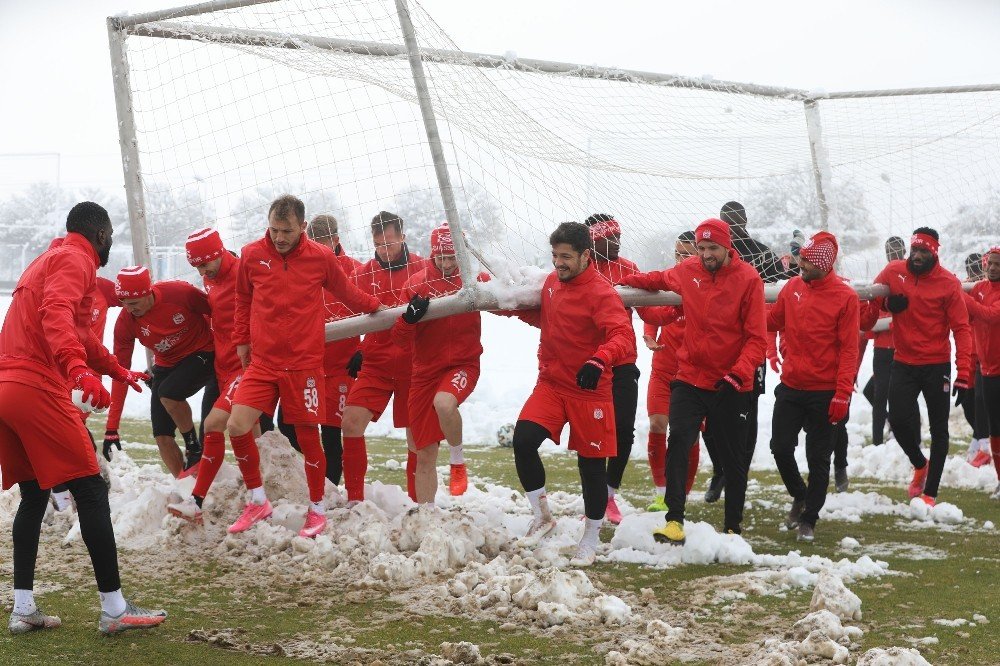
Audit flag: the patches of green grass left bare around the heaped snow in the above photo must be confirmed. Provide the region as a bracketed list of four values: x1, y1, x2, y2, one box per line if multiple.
[0, 420, 1000, 665]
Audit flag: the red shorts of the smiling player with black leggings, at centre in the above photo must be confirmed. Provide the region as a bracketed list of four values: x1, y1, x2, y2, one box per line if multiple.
[517, 383, 618, 458]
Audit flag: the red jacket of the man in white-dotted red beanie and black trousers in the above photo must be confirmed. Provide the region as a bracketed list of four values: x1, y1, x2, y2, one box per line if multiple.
[767, 271, 859, 395]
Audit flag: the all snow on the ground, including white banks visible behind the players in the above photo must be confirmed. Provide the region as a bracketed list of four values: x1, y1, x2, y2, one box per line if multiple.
[0, 286, 996, 665]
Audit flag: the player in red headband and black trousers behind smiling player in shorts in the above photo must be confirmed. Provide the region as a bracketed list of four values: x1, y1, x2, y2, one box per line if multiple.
[584, 213, 646, 525]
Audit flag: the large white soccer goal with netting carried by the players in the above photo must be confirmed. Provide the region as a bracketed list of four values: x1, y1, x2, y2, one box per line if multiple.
[108, 0, 1000, 332]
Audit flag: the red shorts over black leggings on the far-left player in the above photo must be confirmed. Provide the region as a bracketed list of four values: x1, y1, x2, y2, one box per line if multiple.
[0, 381, 100, 490]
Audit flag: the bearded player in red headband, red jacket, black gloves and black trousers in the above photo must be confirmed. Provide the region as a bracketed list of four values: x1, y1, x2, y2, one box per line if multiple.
[874, 227, 972, 506]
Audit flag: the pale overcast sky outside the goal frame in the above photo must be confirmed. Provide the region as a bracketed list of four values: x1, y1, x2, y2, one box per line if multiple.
[0, 0, 1000, 196]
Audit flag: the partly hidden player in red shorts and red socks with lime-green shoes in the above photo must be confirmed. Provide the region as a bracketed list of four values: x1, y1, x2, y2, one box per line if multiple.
[643, 231, 701, 511]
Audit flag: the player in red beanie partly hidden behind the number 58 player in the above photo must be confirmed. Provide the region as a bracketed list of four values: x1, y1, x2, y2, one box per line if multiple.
[167, 228, 243, 525]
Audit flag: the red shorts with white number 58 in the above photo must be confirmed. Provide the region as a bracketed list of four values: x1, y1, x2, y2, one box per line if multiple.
[233, 363, 326, 425]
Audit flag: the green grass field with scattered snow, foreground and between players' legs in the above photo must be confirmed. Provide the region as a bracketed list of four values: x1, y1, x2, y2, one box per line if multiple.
[0, 422, 1000, 665]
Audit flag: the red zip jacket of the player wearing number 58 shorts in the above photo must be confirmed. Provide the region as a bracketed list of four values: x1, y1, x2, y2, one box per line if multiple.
[233, 234, 380, 371]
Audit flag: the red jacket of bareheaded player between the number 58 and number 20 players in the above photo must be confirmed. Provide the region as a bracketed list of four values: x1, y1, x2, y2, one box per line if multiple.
[351, 248, 425, 378]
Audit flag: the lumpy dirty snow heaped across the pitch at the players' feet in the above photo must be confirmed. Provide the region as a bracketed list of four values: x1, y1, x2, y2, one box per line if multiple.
[0, 432, 964, 664]
